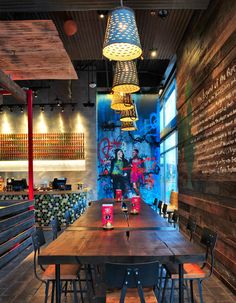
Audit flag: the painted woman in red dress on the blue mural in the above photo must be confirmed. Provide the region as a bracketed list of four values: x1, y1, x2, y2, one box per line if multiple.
[130, 148, 144, 194]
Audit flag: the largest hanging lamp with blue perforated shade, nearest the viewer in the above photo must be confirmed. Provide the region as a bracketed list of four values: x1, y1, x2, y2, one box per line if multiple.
[103, 0, 142, 61]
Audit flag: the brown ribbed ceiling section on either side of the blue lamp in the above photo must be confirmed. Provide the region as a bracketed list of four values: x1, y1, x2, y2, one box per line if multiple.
[0, 10, 193, 61]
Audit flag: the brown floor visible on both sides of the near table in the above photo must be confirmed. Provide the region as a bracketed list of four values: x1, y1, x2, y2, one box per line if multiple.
[0, 234, 236, 303]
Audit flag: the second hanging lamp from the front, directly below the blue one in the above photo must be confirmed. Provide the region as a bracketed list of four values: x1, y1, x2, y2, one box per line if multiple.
[112, 61, 140, 94]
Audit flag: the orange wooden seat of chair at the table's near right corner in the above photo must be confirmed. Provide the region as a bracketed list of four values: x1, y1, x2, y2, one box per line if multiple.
[165, 262, 206, 280]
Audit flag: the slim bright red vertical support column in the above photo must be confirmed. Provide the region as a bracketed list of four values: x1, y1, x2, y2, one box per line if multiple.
[27, 89, 34, 200]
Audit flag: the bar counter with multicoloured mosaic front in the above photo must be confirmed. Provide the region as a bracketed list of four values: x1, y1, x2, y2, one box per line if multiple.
[0, 189, 89, 226]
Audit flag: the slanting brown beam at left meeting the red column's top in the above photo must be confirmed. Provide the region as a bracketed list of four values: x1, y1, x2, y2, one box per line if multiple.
[0, 70, 26, 102]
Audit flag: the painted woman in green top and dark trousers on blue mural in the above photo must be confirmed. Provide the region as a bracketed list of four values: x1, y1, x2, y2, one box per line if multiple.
[111, 148, 129, 197]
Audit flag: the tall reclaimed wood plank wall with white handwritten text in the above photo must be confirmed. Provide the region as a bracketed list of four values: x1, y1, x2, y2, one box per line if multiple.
[177, 0, 236, 291]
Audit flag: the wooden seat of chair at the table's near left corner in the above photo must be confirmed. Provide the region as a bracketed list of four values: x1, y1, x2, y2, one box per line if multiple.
[42, 264, 81, 280]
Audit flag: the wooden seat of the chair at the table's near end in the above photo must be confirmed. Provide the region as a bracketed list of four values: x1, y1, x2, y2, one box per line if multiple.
[106, 288, 158, 303]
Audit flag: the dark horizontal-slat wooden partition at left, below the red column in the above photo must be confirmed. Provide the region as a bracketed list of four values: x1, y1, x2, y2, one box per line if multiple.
[0, 200, 35, 268]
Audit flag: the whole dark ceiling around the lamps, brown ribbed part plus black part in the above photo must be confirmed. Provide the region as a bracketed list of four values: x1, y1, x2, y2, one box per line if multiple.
[0, 0, 209, 91]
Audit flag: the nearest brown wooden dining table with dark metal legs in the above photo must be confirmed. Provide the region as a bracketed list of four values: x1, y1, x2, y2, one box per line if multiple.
[38, 201, 205, 303]
